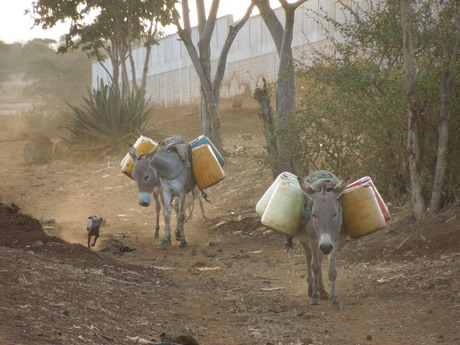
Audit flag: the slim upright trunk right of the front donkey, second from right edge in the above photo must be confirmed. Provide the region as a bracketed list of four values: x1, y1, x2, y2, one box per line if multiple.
[401, 0, 426, 219]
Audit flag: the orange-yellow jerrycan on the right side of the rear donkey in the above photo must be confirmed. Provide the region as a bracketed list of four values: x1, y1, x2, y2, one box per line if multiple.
[192, 144, 225, 189]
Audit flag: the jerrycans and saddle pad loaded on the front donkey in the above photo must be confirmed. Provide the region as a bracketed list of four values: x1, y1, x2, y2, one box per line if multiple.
[256, 170, 390, 238]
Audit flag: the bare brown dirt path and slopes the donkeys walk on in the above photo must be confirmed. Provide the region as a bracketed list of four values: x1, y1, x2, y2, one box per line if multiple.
[0, 99, 460, 345]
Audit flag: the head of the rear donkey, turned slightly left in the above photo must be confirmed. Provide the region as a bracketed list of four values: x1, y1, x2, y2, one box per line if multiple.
[129, 145, 158, 207]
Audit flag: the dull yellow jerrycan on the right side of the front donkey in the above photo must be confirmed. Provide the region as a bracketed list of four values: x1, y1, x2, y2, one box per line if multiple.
[341, 184, 386, 238]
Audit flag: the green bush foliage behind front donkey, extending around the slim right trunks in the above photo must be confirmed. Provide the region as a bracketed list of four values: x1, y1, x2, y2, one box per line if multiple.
[291, 0, 460, 202]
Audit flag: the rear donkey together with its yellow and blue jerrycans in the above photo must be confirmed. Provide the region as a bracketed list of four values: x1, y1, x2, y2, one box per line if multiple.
[121, 136, 225, 249]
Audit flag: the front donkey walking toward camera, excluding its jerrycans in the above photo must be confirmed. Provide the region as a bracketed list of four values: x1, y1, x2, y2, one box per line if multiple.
[287, 170, 348, 310]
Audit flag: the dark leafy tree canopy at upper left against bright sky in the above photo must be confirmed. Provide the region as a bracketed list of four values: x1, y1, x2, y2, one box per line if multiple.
[26, 0, 177, 59]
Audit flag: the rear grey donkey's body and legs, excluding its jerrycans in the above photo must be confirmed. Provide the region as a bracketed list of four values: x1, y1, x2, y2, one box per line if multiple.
[129, 137, 196, 249]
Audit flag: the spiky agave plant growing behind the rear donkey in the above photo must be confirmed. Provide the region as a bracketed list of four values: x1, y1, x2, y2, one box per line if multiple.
[65, 83, 155, 158]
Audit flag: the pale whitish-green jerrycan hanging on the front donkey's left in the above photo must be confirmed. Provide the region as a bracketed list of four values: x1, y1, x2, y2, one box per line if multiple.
[261, 181, 306, 237]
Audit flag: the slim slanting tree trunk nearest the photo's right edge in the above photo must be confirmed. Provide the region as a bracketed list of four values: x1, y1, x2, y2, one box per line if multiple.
[430, 7, 460, 211]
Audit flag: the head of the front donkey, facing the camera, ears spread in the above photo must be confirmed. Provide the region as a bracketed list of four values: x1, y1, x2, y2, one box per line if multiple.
[298, 177, 348, 255]
